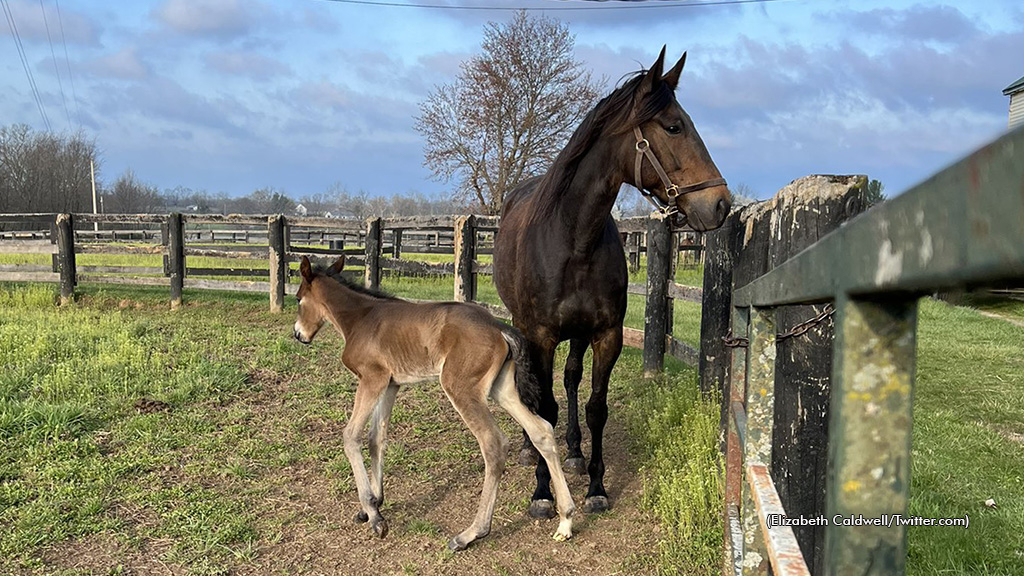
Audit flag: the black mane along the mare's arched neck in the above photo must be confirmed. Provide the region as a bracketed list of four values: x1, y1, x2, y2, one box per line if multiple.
[532, 70, 675, 217]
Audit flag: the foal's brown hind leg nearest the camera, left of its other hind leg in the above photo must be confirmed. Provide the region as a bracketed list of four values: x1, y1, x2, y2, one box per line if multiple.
[441, 372, 509, 551]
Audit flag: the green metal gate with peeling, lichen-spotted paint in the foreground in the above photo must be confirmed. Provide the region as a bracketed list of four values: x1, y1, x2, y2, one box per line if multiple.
[723, 124, 1024, 575]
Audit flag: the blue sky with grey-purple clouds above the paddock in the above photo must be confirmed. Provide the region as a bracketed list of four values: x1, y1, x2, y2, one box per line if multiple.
[0, 0, 1024, 198]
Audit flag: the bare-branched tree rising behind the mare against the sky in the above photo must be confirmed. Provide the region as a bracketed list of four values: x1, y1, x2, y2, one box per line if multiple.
[416, 11, 602, 214]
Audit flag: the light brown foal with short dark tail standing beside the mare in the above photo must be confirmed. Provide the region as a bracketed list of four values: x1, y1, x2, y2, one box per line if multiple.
[294, 256, 575, 550]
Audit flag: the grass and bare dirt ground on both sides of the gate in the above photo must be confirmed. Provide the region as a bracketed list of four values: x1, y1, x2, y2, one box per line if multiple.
[0, 266, 1024, 575]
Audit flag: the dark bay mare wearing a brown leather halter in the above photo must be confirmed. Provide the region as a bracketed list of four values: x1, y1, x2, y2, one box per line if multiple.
[494, 47, 731, 518]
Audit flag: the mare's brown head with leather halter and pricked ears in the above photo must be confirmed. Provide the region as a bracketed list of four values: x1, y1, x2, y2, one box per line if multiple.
[609, 47, 731, 231]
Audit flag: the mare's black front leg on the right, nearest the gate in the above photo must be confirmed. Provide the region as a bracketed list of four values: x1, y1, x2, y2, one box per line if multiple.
[583, 326, 623, 512]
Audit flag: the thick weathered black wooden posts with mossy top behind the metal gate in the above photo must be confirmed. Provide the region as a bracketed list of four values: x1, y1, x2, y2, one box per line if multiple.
[699, 175, 867, 573]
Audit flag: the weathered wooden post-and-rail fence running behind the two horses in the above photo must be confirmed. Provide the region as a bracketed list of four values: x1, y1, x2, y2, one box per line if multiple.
[0, 213, 703, 362]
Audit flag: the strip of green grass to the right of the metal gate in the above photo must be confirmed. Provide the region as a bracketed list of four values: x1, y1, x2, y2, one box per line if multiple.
[907, 299, 1024, 575]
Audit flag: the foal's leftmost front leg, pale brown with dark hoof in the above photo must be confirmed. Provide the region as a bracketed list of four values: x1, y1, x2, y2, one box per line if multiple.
[344, 374, 391, 538]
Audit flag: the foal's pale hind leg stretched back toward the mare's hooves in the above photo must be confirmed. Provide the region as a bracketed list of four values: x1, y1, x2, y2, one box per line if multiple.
[492, 367, 575, 540]
